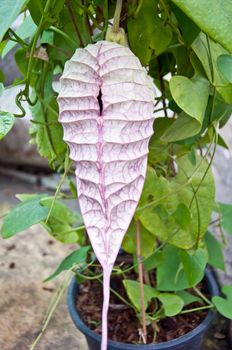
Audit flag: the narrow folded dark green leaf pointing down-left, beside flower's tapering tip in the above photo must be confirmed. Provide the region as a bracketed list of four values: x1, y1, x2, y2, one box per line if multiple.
[44, 246, 90, 282]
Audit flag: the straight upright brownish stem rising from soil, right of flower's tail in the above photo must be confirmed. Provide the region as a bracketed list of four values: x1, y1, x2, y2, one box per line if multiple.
[136, 221, 147, 344]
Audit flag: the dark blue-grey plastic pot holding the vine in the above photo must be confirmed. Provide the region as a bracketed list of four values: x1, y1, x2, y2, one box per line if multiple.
[67, 269, 219, 350]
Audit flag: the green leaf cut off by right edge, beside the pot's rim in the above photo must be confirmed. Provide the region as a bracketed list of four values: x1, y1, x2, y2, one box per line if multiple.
[212, 286, 232, 320]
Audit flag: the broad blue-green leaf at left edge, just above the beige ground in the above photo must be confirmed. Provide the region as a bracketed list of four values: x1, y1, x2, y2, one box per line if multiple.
[1, 196, 48, 238]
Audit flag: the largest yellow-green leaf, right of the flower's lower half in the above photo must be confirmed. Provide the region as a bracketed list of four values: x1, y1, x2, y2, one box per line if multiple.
[136, 156, 214, 249]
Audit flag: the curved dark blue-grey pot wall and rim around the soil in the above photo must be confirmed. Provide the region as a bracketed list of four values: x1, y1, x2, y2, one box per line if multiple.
[67, 268, 219, 350]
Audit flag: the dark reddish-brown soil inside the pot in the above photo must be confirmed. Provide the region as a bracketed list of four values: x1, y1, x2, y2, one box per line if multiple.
[76, 268, 207, 344]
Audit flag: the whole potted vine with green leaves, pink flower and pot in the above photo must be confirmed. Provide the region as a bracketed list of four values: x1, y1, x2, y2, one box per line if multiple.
[0, 0, 232, 350]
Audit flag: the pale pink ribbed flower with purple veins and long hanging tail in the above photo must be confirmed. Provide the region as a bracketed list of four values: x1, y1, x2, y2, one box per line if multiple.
[58, 41, 154, 350]
